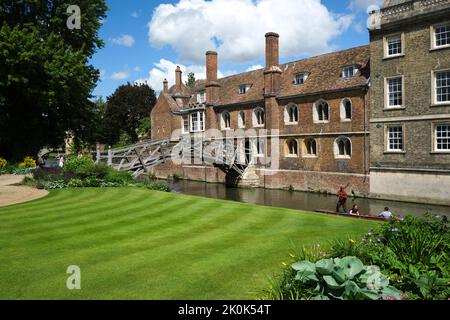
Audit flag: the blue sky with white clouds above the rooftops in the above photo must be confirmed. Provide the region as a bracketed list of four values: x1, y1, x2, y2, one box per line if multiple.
[91, 0, 380, 97]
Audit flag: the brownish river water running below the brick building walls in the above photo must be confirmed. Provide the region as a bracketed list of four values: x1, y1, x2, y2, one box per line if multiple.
[155, 180, 450, 217]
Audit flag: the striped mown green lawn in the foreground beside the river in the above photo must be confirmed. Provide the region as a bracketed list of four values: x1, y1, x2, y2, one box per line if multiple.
[0, 188, 376, 299]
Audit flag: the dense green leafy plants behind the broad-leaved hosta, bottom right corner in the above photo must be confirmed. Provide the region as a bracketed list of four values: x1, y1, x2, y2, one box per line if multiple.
[329, 213, 450, 299]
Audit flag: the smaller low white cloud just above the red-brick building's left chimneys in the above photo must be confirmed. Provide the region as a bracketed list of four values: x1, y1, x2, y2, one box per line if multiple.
[135, 59, 230, 91]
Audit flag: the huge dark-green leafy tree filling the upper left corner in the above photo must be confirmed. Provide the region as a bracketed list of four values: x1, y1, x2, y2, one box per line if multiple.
[0, 0, 107, 159]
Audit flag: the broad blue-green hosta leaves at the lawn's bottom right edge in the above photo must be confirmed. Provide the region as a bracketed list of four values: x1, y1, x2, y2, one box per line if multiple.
[268, 257, 401, 300]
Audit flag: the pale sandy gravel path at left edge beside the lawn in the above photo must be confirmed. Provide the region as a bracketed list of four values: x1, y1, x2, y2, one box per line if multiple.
[0, 174, 48, 207]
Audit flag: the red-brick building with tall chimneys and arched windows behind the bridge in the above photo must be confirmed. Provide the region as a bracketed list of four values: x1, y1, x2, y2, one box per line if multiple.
[152, 33, 369, 195]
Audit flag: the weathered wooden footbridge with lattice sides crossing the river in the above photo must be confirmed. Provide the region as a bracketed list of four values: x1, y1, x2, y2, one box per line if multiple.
[97, 139, 250, 181]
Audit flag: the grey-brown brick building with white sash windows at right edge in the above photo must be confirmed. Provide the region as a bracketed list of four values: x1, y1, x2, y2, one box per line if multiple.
[370, 0, 450, 205]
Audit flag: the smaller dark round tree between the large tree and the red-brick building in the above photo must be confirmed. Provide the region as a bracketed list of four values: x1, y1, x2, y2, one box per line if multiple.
[103, 83, 156, 145]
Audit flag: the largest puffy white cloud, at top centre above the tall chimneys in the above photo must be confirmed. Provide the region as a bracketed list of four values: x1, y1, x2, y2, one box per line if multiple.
[148, 0, 353, 64]
